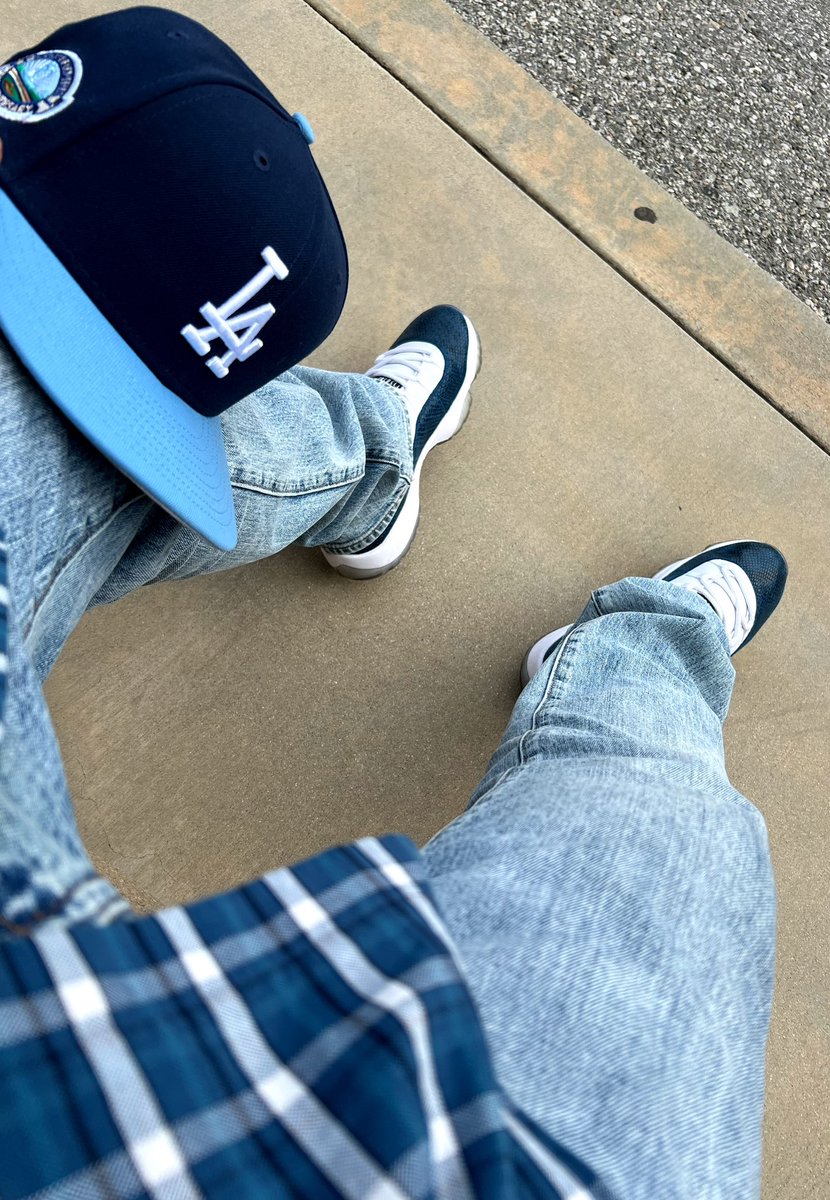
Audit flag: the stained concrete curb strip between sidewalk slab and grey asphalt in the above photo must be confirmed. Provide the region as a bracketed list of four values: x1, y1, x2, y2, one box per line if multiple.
[306, 0, 830, 451]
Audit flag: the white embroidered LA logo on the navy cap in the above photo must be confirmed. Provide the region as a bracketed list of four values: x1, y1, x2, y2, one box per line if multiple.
[181, 246, 288, 379]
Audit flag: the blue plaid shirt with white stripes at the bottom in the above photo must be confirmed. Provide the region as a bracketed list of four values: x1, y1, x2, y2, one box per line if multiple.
[0, 547, 608, 1200]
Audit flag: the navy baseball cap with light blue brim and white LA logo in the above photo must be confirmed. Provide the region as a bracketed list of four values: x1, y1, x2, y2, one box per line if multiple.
[0, 7, 348, 550]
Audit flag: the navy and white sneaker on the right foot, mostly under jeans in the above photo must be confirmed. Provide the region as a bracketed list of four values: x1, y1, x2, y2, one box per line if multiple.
[521, 540, 787, 688]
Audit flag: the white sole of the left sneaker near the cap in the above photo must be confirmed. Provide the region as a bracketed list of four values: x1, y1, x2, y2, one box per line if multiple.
[323, 314, 481, 580]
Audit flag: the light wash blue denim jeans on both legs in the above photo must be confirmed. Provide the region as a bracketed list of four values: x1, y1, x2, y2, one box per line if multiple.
[0, 340, 775, 1200]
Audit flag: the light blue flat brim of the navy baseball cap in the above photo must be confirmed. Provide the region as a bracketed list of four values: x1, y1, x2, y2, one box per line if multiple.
[0, 192, 236, 550]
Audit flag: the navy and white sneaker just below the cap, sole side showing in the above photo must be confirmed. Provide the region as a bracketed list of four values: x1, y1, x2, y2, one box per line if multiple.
[323, 305, 481, 580]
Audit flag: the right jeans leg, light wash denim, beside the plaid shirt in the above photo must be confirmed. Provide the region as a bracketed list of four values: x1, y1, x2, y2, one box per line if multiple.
[425, 568, 775, 1200]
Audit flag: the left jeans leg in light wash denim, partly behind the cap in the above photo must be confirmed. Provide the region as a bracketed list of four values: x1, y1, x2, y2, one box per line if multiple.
[0, 337, 411, 937]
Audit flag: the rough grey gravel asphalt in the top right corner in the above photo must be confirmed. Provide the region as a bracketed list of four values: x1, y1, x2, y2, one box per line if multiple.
[450, 0, 830, 320]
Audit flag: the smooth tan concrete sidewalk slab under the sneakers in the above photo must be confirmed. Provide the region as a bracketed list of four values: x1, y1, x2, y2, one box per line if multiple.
[0, 0, 830, 1200]
